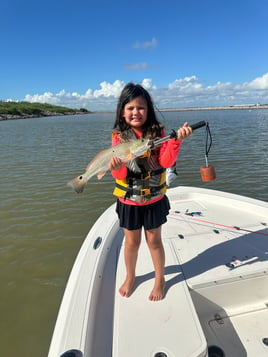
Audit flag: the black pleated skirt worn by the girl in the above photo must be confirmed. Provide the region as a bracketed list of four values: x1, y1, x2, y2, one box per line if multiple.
[116, 196, 170, 231]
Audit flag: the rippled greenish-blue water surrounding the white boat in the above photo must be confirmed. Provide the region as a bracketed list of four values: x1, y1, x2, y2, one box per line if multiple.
[0, 110, 268, 357]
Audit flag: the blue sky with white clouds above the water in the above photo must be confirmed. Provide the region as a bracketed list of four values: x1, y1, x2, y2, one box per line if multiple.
[0, 0, 268, 111]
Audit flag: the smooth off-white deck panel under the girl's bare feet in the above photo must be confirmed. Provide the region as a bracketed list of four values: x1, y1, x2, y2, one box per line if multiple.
[113, 236, 206, 357]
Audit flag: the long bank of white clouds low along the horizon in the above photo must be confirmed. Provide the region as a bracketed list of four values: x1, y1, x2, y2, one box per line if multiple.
[21, 73, 268, 110]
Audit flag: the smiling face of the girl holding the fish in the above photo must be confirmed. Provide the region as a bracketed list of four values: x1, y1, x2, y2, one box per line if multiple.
[123, 97, 148, 131]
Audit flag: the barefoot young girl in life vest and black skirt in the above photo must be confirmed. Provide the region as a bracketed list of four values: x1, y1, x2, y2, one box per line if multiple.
[109, 83, 192, 301]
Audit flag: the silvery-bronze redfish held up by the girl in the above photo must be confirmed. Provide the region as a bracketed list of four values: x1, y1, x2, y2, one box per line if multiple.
[68, 139, 150, 193]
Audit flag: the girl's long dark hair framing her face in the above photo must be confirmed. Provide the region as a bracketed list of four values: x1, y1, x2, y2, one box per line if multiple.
[113, 83, 163, 138]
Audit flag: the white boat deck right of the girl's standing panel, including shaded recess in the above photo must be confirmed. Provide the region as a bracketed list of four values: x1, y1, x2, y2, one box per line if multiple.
[163, 188, 268, 357]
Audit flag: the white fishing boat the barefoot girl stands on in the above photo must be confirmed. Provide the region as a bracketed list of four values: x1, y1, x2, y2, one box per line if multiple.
[48, 186, 268, 357]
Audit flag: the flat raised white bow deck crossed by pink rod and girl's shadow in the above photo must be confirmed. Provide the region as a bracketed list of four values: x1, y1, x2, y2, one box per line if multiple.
[166, 196, 268, 288]
